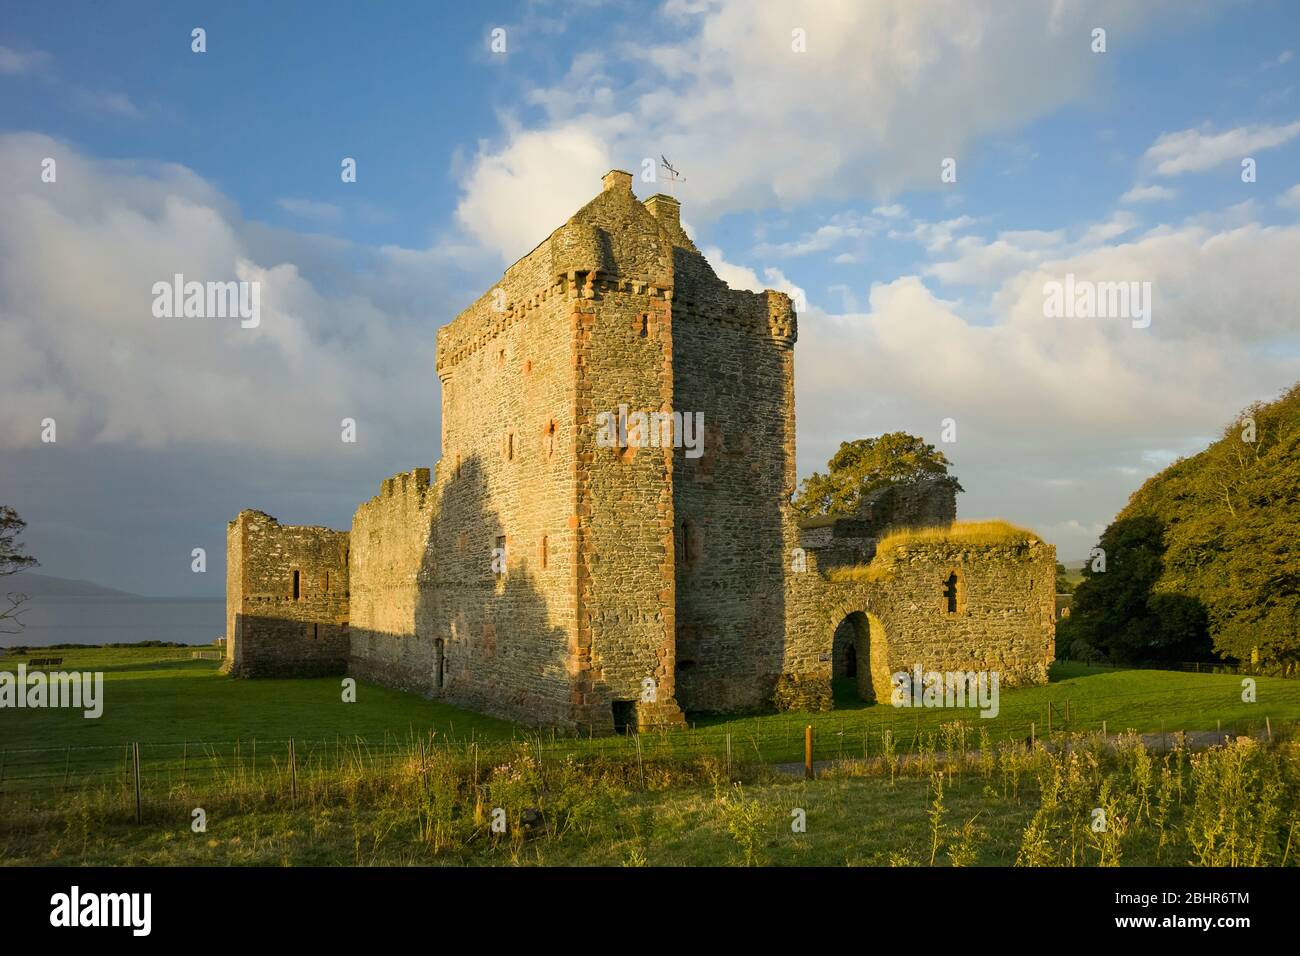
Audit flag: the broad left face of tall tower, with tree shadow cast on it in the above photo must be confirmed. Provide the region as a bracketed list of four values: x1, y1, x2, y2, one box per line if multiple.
[430, 209, 577, 726]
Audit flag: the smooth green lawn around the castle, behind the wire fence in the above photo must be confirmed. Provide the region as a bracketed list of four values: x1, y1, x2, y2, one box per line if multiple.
[0, 648, 1300, 786]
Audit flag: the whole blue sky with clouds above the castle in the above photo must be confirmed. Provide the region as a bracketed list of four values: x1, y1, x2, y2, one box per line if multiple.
[0, 0, 1300, 596]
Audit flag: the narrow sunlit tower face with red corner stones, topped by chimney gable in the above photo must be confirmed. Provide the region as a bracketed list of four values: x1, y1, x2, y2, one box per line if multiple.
[573, 170, 683, 731]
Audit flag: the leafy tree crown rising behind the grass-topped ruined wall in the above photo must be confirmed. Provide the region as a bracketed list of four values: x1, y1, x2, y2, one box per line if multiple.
[794, 432, 962, 518]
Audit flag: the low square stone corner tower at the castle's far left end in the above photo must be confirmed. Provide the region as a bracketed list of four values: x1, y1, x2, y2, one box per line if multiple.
[226, 511, 348, 678]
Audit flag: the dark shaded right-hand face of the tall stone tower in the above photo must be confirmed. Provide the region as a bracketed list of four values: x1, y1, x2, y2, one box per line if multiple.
[672, 227, 796, 711]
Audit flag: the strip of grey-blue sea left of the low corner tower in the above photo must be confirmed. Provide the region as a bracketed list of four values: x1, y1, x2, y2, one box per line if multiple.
[0, 594, 226, 648]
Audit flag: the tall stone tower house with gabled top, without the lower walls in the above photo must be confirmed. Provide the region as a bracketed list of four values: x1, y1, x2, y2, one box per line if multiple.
[430, 170, 794, 731]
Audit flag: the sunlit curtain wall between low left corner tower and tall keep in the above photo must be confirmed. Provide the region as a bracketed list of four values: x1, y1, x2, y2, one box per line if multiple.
[348, 468, 442, 695]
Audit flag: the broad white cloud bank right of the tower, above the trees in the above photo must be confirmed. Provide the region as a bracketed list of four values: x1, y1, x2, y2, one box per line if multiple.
[796, 214, 1300, 557]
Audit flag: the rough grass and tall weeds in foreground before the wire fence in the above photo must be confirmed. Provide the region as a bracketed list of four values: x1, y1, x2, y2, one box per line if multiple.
[0, 735, 1300, 866]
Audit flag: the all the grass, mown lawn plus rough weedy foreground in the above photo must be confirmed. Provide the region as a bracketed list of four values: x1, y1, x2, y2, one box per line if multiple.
[0, 648, 1300, 865]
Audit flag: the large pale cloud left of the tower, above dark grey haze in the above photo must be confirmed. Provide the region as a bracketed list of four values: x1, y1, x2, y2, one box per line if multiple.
[0, 134, 475, 460]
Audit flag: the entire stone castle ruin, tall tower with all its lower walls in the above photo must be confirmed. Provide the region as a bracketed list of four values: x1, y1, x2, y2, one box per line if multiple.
[226, 170, 1056, 734]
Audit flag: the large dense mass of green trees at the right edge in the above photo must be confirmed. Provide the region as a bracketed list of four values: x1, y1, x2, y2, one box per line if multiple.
[1057, 384, 1300, 672]
